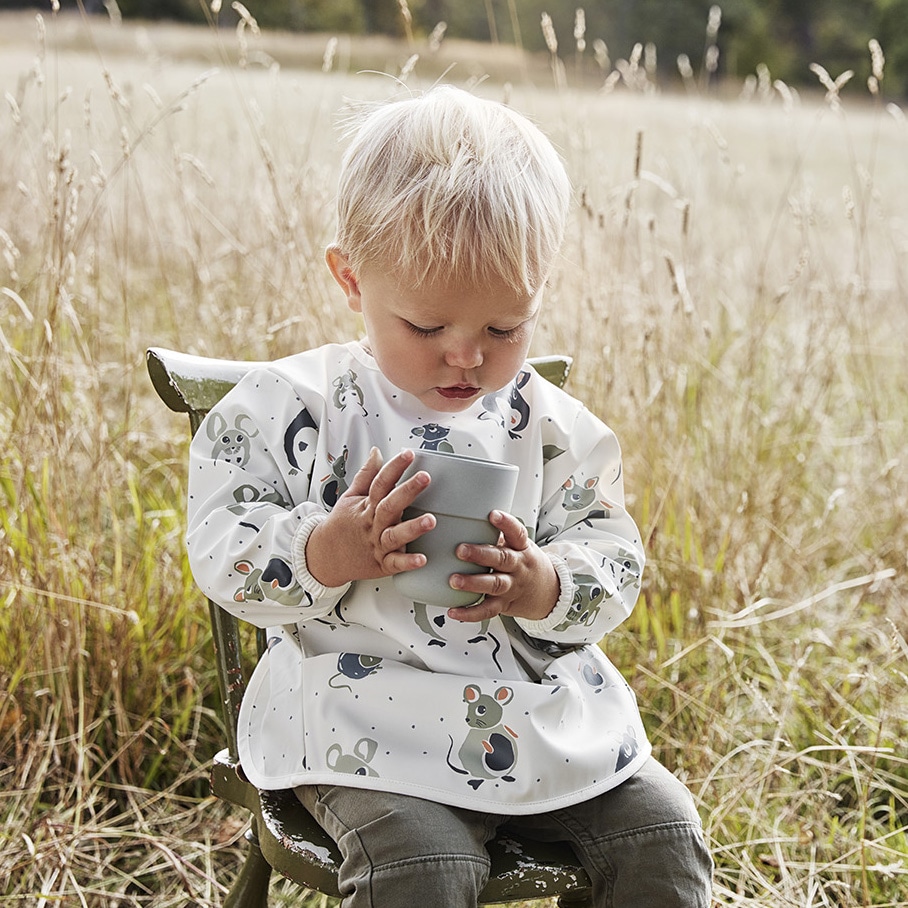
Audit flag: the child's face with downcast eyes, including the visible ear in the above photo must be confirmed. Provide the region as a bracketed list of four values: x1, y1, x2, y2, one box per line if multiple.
[327, 247, 542, 413]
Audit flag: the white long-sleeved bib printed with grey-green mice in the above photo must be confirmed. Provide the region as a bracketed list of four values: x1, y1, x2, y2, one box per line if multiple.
[188, 343, 650, 814]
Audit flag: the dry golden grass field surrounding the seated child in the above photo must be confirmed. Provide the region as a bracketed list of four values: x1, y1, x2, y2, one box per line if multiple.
[0, 7, 908, 908]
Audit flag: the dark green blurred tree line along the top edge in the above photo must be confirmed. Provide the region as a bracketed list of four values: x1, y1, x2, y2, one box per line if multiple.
[0, 0, 908, 96]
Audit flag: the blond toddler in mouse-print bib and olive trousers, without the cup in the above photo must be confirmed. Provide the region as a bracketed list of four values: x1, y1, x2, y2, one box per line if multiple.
[188, 86, 711, 908]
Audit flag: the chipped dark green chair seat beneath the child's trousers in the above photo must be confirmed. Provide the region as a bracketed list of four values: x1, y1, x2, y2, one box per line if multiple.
[211, 750, 590, 904]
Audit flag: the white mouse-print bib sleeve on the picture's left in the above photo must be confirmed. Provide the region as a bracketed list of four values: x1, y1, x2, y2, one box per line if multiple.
[187, 370, 350, 627]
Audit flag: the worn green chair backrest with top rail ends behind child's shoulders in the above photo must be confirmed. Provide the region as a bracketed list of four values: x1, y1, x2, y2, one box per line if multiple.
[146, 347, 572, 761]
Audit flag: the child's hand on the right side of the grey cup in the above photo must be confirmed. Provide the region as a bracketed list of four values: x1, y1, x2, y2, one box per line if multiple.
[448, 511, 561, 621]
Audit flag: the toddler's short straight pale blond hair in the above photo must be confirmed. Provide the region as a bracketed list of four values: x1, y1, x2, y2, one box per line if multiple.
[336, 86, 570, 294]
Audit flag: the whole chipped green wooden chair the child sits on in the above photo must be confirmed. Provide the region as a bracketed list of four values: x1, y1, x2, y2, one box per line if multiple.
[147, 348, 591, 908]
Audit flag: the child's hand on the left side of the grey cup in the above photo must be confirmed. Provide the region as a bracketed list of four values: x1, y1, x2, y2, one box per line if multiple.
[306, 448, 435, 587]
